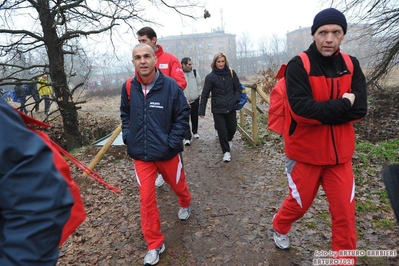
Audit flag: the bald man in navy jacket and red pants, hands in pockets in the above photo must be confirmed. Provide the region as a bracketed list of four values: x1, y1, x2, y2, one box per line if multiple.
[120, 43, 191, 265]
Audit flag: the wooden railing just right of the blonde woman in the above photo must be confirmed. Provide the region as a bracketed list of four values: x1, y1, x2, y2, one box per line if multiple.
[237, 83, 270, 146]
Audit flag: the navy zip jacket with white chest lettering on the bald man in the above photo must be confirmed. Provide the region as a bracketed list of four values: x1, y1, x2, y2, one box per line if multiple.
[120, 69, 190, 161]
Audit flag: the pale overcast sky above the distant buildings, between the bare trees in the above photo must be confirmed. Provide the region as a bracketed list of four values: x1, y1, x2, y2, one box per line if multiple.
[150, 0, 327, 41]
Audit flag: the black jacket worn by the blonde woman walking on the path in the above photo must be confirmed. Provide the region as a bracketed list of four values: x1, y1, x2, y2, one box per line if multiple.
[198, 67, 241, 115]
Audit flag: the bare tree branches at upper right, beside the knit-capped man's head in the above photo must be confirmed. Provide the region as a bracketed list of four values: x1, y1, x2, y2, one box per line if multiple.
[331, 0, 399, 83]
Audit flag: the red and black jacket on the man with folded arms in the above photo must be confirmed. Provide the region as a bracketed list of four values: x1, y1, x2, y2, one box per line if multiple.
[284, 44, 367, 165]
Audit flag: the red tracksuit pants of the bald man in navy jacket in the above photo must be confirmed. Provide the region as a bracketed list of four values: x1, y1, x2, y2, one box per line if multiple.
[133, 155, 191, 250]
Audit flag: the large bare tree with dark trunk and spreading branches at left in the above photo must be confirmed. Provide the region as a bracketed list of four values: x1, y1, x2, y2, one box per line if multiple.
[0, 0, 202, 150]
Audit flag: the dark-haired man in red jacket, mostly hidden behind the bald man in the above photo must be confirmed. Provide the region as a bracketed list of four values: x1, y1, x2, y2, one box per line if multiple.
[137, 27, 187, 187]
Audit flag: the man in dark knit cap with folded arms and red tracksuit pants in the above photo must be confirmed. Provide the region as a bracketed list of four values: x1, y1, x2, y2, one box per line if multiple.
[273, 8, 367, 265]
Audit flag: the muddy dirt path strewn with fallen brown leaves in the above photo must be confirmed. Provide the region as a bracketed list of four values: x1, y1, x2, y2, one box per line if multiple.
[58, 103, 399, 266]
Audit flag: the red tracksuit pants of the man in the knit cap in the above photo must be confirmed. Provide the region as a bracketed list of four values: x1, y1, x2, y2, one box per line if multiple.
[273, 158, 356, 258]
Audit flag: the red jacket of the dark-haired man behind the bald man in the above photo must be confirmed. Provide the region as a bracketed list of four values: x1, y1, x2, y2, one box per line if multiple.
[155, 44, 187, 90]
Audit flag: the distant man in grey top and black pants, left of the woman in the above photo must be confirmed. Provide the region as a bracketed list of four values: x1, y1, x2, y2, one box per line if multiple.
[181, 57, 201, 145]
